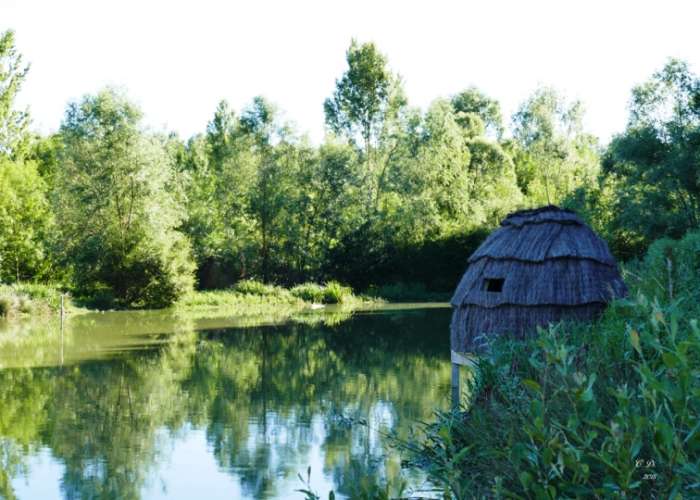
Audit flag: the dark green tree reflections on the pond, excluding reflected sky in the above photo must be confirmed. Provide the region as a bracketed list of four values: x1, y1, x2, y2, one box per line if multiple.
[0, 310, 450, 499]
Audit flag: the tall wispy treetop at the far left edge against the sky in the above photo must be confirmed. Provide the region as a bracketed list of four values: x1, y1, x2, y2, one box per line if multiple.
[0, 30, 29, 157]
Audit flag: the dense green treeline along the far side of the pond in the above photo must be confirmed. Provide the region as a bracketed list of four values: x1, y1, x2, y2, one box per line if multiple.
[0, 31, 700, 307]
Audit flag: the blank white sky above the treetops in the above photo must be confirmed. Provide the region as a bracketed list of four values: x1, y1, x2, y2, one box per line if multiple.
[0, 0, 700, 142]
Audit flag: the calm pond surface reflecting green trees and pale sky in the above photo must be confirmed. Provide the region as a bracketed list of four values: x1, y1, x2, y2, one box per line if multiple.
[0, 304, 451, 500]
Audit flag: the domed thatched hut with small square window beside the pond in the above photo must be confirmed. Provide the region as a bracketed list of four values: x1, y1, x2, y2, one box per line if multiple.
[451, 206, 627, 353]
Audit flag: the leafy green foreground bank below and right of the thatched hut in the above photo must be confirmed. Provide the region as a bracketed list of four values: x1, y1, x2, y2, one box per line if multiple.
[401, 229, 700, 499]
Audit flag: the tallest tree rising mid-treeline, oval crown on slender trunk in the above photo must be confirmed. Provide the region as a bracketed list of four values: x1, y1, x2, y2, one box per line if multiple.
[324, 40, 406, 214]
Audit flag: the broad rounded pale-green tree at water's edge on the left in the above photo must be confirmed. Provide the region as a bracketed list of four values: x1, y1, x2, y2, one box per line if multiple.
[54, 89, 193, 307]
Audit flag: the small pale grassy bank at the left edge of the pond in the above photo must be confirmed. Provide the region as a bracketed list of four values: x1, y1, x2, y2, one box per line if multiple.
[0, 283, 72, 318]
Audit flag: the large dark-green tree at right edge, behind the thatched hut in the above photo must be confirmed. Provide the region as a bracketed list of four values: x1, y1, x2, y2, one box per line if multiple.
[603, 59, 700, 256]
